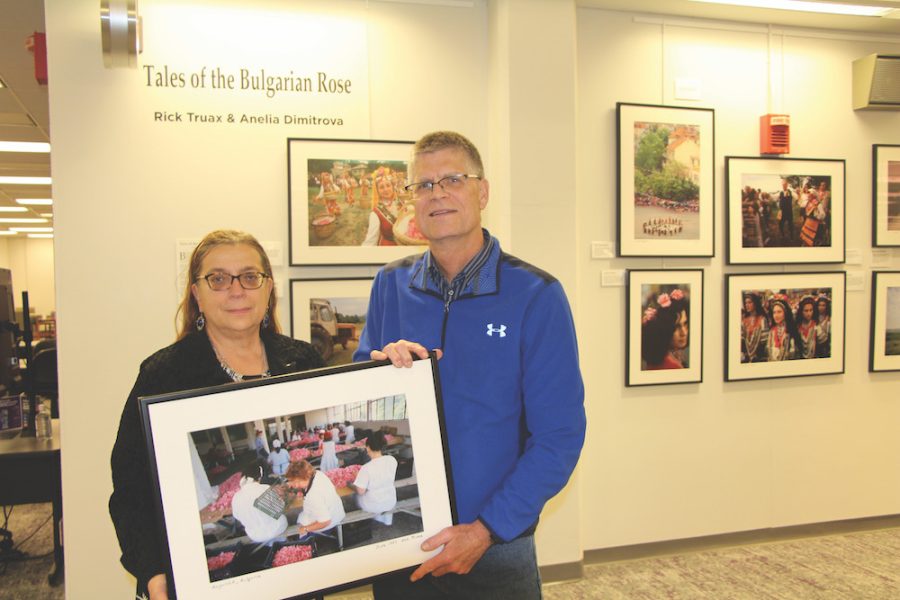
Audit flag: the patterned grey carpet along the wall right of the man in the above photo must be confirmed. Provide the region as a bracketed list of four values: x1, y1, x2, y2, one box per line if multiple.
[544, 529, 900, 600]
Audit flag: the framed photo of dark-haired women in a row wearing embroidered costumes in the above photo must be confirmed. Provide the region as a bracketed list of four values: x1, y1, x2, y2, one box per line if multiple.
[725, 271, 847, 381]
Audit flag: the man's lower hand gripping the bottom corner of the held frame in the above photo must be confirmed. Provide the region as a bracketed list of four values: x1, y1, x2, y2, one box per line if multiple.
[409, 520, 491, 581]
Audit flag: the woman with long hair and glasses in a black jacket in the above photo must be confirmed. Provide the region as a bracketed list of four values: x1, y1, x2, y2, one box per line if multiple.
[109, 231, 323, 600]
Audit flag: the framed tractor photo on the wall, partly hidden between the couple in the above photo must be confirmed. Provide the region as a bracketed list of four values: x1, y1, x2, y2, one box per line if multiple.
[291, 277, 372, 367]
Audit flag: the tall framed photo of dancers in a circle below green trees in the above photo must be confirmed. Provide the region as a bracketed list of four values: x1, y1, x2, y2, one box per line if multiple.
[616, 102, 715, 256]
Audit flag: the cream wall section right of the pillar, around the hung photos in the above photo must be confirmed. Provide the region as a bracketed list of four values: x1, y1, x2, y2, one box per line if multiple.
[577, 9, 900, 549]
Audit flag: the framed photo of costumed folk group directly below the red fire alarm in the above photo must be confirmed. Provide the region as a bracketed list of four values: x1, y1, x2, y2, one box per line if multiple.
[725, 156, 845, 264]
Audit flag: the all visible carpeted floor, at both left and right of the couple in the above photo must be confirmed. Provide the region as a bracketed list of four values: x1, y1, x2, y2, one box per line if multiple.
[0, 504, 900, 600]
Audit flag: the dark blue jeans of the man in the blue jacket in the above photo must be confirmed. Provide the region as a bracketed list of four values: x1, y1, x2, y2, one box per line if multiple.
[372, 535, 541, 600]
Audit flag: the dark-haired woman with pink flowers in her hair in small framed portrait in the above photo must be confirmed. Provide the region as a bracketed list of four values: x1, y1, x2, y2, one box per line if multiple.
[641, 288, 689, 371]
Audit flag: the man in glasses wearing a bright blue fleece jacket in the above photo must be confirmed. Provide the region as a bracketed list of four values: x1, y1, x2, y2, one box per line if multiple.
[354, 132, 585, 600]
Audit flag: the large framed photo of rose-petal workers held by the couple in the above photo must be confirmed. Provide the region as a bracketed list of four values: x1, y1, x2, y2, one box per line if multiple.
[141, 356, 456, 600]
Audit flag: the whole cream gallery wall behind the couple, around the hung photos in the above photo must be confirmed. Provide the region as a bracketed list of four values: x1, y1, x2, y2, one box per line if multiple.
[42, 0, 900, 598]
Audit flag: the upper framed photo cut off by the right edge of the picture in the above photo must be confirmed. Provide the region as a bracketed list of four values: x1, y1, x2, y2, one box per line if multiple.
[872, 144, 900, 246]
